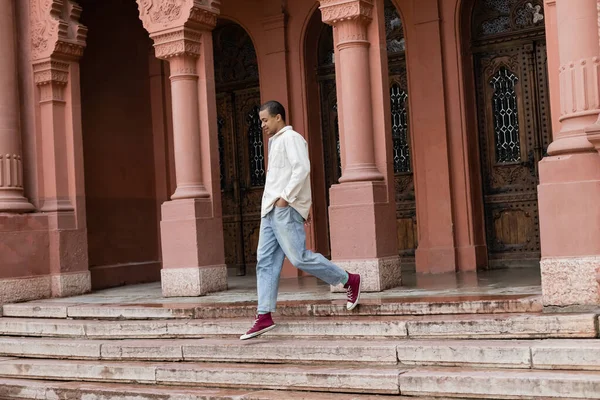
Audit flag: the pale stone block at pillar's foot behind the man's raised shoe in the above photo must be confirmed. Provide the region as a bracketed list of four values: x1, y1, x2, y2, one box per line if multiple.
[331, 256, 402, 292]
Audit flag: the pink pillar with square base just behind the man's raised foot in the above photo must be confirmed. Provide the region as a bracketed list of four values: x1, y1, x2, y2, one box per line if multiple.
[321, 0, 401, 291]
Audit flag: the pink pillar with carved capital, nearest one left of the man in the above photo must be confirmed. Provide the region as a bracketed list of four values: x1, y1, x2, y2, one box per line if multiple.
[138, 0, 227, 297]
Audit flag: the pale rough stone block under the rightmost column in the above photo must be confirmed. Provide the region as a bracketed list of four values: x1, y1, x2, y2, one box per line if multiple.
[540, 256, 600, 307]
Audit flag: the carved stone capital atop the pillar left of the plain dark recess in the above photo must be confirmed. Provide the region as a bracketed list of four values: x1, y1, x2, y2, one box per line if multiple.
[29, 0, 87, 60]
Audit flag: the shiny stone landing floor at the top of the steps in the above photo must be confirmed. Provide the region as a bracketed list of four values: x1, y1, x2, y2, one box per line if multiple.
[29, 269, 541, 306]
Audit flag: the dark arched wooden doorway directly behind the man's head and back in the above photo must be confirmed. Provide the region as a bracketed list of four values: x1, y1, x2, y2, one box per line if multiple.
[213, 20, 266, 275]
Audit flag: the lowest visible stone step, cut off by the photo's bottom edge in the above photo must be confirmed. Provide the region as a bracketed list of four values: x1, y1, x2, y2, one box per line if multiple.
[0, 379, 464, 400]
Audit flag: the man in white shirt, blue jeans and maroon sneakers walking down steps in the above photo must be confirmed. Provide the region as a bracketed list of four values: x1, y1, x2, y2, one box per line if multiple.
[240, 101, 360, 340]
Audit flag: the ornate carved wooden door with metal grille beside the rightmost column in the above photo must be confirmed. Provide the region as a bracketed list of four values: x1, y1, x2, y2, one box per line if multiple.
[473, 0, 552, 267]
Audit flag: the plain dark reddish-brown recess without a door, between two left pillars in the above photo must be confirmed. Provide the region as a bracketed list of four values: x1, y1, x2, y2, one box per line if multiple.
[79, 0, 161, 289]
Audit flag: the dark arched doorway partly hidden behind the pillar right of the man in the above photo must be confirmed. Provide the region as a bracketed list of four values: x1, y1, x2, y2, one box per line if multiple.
[305, 0, 417, 264]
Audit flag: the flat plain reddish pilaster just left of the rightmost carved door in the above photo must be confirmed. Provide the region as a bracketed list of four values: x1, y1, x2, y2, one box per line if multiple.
[405, 0, 460, 273]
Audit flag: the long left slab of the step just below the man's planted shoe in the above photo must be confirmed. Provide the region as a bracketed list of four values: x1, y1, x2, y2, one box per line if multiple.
[0, 337, 399, 365]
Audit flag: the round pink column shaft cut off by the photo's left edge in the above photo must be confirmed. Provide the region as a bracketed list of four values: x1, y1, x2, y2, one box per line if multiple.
[0, 0, 34, 212]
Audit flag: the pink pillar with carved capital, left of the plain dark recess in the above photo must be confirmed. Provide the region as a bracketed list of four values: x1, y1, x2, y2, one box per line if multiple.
[29, 0, 91, 297]
